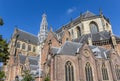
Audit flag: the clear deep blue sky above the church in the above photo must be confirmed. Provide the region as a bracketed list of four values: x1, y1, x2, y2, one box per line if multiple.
[0, 0, 120, 40]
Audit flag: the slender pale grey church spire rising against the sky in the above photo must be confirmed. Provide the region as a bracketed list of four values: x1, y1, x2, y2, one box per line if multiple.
[38, 13, 48, 43]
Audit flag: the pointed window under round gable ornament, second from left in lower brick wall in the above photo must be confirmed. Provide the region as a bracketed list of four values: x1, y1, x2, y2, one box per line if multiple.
[85, 62, 93, 81]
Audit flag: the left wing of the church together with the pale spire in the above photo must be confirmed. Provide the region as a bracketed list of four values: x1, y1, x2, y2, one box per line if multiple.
[5, 14, 48, 81]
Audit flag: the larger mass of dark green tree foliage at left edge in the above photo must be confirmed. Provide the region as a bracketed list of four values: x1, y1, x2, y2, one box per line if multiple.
[0, 35, 9, 64]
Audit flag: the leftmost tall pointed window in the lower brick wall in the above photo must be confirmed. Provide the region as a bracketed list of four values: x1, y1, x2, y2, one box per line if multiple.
[65, 61, 74, 81]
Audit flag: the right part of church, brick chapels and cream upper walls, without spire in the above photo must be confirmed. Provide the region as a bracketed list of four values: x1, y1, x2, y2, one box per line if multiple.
[41, 11, 120, 81]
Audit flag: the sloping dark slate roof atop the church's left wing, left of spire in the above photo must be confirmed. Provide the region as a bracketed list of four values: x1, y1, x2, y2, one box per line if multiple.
[13, 29, 39, 45]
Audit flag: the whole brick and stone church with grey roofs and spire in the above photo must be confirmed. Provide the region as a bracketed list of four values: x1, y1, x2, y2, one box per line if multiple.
[5, 11, 120, 81]
